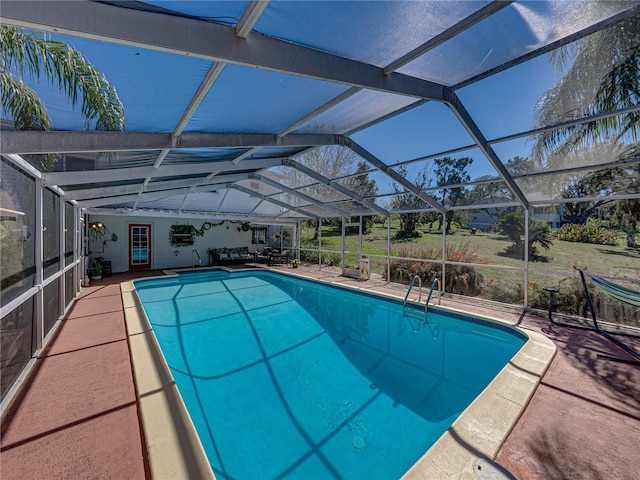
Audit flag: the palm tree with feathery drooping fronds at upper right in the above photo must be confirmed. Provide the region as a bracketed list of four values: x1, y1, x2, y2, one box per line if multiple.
[534, 13, 640, 159]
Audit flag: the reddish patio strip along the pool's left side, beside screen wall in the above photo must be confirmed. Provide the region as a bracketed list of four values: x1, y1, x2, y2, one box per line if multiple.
[0, 276, 150, 480]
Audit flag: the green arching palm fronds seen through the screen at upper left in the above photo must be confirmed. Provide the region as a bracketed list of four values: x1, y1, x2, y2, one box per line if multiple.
[0, 25, 124, 137]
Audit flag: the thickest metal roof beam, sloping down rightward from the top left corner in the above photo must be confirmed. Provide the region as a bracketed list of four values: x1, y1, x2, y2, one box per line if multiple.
[2, 0, 444, 101]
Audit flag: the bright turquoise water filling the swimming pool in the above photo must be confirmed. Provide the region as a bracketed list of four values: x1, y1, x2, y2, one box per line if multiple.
[135, 270, 526, 480]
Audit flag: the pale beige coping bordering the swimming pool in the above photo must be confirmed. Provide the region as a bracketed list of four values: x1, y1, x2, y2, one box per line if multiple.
[121, 272, 557, 480]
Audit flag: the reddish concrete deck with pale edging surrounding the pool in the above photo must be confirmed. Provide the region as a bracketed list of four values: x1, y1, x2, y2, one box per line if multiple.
[0, 267, 640, 480]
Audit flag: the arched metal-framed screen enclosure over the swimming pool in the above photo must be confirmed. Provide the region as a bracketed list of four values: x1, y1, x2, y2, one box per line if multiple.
[0, 0, 640, 405]
